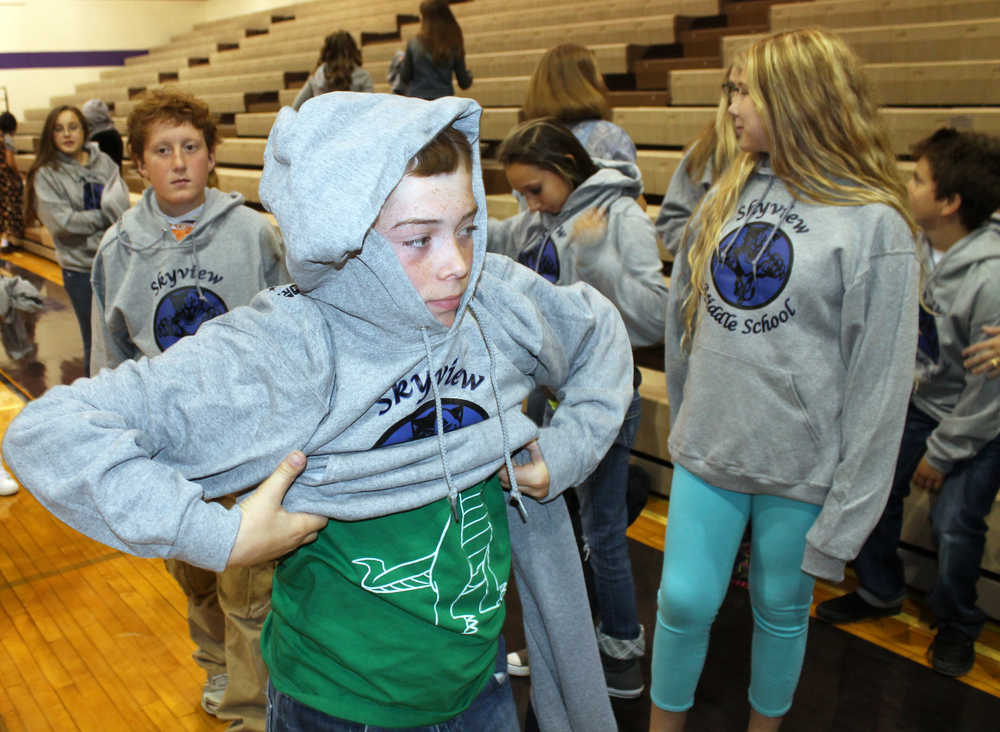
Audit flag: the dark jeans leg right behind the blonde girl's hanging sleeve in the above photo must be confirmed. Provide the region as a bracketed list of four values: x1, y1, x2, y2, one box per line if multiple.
[854, 404, 937, 606]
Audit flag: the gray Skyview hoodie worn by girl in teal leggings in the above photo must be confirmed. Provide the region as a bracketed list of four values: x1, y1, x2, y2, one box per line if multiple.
[666, 162, 919, 581]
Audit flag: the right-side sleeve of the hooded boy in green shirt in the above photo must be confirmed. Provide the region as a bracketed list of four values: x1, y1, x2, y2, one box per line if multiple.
[496, 254, 633, 500]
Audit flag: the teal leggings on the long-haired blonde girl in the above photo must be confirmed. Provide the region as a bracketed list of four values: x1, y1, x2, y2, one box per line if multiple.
[650, 464, 820, 717]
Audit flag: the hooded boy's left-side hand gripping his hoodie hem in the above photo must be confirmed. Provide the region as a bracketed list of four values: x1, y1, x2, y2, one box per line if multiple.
[226, 450, 327, 567]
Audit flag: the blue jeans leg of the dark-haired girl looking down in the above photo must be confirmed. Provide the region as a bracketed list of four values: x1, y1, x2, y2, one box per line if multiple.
[577, 389, 641, 640]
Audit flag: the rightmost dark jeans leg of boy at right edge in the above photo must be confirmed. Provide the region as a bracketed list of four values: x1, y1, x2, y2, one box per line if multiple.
[927, 437, 1000, 639]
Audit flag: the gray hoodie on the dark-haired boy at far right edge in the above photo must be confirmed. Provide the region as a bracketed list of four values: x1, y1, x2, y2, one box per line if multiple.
[911, 224, 1000, 473]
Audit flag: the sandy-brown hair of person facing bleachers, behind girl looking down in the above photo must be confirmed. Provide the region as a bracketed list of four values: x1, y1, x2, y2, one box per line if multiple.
[524, 43, 611, 124]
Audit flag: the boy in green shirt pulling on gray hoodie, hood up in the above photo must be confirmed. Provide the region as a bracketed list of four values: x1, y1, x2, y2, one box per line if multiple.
[4, 92, 632, 730]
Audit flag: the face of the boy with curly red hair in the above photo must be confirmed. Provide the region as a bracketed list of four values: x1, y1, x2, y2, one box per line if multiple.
[136, 121, 215, 216]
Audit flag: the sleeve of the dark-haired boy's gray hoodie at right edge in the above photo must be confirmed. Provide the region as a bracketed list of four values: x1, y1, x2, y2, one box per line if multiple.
[917, 260, 1000, 473]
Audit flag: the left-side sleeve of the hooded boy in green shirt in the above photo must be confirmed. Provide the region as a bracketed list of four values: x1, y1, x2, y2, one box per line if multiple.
[3, 296, 332, 571]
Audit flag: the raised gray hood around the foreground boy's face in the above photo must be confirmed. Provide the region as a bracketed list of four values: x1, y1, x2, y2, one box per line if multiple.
[260, 92, 486, 339]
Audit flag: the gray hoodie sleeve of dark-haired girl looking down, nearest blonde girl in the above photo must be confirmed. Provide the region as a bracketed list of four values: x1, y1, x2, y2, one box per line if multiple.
[572, 198, 667, 347]
